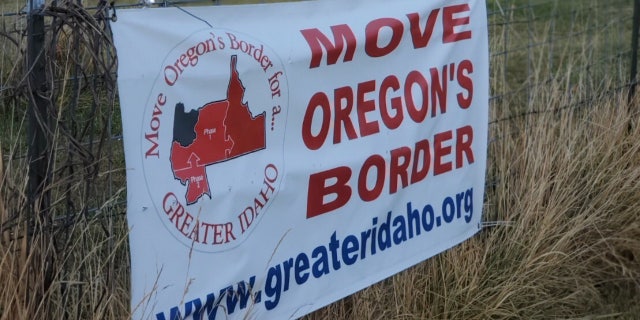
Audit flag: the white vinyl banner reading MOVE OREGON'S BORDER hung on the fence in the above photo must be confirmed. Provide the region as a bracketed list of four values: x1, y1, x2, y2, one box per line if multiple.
[112, 0, 489, 319]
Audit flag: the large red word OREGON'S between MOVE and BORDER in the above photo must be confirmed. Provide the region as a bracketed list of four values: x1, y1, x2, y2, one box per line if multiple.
[302, 60, 473, 150]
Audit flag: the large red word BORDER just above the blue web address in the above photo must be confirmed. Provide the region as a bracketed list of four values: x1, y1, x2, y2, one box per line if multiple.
[307, 125, 474, 214]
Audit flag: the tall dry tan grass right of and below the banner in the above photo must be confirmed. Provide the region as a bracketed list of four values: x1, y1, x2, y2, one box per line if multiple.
[308, 84, 640, 319]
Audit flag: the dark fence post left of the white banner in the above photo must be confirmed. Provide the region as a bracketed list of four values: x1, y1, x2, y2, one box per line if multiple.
[26, 0, 53, 299]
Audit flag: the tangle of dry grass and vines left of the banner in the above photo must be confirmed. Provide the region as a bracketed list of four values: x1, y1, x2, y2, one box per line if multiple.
[0, 0, 129, 319]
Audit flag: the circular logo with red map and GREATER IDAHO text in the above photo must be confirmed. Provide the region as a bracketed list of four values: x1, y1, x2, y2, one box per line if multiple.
[141, 29, 288, 252]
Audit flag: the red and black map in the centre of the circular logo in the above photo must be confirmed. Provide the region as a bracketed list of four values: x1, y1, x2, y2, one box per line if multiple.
[170, 55, 266, 204]
